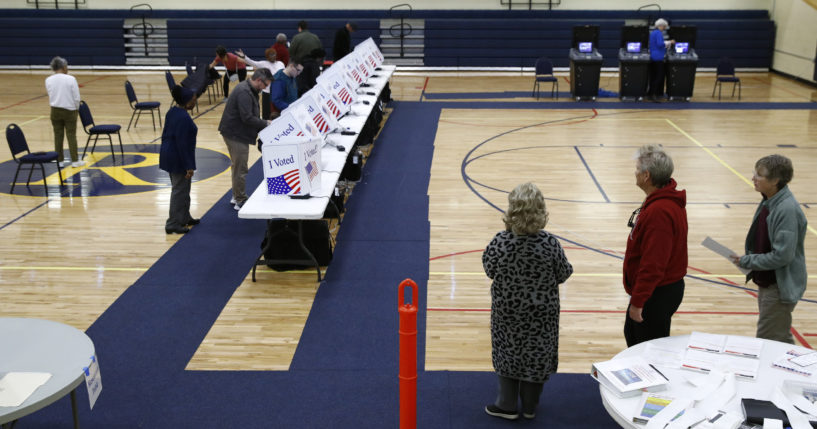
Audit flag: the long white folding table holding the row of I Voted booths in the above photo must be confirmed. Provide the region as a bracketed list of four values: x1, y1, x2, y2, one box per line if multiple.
[238, 65, 396, 281]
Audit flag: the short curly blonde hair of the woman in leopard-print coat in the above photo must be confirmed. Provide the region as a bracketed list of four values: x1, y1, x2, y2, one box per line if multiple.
[502, 182, 548, 235]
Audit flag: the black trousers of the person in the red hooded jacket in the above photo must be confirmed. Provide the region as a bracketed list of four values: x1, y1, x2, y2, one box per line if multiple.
[624, 279, 684, 347]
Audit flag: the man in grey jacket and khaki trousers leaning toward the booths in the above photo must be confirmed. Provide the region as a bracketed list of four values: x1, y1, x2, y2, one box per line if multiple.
[218, 68, 272, 210]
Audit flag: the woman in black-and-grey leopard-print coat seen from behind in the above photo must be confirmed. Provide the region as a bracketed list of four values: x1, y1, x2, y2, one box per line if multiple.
[482, 183, 573, 420]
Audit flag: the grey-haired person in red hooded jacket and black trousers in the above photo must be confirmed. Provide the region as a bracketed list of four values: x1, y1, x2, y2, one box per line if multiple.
[624, 145, 687, 347]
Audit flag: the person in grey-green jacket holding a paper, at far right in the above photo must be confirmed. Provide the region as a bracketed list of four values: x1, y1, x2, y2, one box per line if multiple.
[731, 155, 808, 344]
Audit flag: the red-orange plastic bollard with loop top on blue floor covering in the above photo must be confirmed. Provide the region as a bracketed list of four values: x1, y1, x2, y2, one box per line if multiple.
[397, 279, 417, 429]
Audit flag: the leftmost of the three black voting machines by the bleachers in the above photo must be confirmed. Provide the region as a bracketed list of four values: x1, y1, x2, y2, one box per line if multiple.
[570, 25, 602, 101]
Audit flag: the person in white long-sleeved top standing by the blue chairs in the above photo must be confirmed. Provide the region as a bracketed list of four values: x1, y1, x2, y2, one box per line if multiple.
[45, 57, 85, 167]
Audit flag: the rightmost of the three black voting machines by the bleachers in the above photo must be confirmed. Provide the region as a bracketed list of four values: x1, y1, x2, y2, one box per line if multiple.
[667, 25, 698, 101]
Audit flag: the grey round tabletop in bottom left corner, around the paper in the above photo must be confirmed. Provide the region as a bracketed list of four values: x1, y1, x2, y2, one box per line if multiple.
[0, 317, 95, 424]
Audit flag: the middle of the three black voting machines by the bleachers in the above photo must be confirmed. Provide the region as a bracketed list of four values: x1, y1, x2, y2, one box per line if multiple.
[618, 25, 650, 101]
